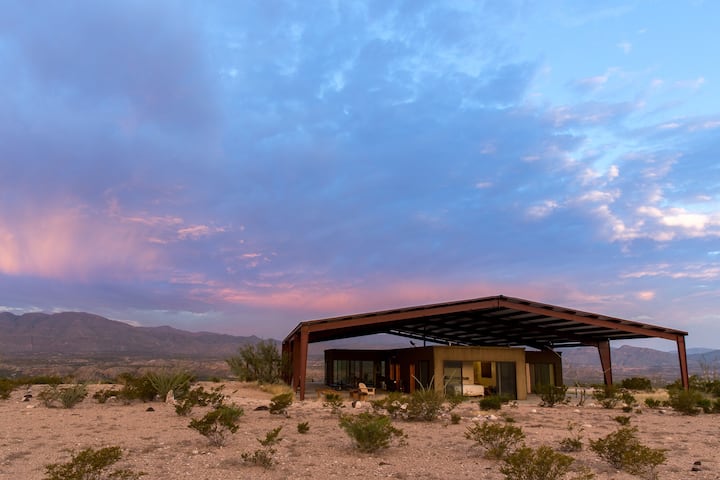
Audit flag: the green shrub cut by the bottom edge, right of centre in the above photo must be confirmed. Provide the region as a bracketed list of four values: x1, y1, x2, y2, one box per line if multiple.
[500, 445, 574, 480]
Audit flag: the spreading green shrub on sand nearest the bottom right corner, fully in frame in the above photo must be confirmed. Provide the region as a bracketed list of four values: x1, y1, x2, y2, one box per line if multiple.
[590, 427, 665, 477]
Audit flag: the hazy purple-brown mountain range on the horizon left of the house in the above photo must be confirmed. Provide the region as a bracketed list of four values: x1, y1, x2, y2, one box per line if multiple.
[0, 312, 259, 358]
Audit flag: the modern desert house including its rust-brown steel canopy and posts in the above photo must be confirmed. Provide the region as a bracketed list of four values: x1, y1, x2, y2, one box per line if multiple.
[282, 295, 688, 399]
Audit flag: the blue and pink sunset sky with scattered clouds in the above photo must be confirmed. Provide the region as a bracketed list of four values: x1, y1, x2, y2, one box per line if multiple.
[0, 0, 720, 349]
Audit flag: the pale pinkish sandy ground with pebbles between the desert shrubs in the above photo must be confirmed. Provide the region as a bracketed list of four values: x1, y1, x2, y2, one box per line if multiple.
[0, 382, 720, 480]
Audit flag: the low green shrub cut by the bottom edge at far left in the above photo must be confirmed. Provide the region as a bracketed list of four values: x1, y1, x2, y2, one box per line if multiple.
[45, 447, 144, 480]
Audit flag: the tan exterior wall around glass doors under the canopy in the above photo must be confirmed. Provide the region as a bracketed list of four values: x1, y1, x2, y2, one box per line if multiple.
[433, 347, 527, 400]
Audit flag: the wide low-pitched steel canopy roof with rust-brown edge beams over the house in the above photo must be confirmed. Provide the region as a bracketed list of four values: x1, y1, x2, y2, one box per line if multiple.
[286, 295, 687, 348]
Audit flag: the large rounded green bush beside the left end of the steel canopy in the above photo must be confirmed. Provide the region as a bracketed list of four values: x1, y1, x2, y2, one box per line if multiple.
[225, 340, 283, 383]
